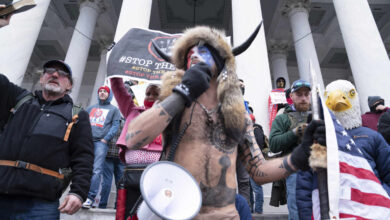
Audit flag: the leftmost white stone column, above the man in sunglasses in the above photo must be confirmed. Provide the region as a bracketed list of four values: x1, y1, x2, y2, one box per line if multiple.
[0, 0, 50, 85]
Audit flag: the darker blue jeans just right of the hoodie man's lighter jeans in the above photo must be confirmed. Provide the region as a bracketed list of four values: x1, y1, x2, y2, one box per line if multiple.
[99, 157, 125, 209]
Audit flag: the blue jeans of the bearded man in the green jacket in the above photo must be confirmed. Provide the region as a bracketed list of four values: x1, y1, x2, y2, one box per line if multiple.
[286, 173, 299, 220]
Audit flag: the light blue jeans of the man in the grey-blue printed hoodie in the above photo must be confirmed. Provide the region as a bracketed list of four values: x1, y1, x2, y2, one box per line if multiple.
[88, 141, 108, 201]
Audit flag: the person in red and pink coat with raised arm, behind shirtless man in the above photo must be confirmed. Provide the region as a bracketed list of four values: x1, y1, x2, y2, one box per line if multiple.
[110, 78, 162, 219]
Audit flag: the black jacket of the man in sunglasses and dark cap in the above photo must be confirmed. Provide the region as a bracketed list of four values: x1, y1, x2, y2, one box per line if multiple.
[0, 74, 93, 201]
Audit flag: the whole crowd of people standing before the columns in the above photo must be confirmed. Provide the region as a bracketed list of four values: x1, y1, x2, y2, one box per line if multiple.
[0, 6, 390, 220]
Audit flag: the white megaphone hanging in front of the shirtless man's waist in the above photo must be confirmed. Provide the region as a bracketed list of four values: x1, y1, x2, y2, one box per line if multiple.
[137, 161, 202, 220]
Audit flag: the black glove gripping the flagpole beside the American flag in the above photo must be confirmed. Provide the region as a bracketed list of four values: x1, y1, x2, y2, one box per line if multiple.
[291, 120, 326, 170]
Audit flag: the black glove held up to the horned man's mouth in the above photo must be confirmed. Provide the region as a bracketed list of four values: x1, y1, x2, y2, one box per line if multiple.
[173, 62, 211, 107]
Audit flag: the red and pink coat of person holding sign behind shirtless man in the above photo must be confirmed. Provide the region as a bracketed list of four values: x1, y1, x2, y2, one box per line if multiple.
[111, 78, 162, 161]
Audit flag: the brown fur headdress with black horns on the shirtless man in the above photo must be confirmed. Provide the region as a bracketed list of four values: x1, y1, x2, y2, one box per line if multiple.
[153, 22, 262, 141]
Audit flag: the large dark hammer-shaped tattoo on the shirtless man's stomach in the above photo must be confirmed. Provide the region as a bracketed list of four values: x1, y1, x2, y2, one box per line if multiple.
[200, 155, 236, 207]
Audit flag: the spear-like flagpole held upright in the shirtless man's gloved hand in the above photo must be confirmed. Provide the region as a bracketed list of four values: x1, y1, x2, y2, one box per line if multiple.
[309, 60, 330, 220]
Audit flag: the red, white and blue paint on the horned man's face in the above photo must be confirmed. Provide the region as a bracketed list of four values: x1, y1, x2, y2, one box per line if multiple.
[187, 46, 215, 69]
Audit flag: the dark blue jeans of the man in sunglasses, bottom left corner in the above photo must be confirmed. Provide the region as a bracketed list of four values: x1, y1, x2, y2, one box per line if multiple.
[0, 195, 60, 220]
